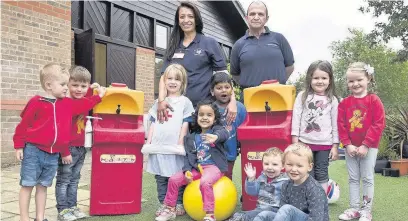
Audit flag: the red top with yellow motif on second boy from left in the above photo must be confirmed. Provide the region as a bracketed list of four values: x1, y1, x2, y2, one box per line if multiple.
[69, 88, 93, 147]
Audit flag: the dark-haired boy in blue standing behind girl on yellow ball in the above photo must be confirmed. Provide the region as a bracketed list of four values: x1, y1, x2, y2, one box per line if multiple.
[211, 71, 247, 180]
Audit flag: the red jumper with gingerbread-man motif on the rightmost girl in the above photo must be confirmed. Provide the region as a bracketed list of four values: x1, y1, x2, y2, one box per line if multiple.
[337, 94, 385, 148]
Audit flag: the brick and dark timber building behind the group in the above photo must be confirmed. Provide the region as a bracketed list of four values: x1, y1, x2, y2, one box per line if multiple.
[1, 1, 246, 166]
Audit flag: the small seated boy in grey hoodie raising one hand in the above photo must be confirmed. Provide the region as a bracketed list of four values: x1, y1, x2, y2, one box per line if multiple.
[230, 147, 289, 221]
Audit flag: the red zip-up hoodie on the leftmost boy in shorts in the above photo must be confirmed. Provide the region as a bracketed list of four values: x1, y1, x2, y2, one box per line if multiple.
[13, 95, 101, 157]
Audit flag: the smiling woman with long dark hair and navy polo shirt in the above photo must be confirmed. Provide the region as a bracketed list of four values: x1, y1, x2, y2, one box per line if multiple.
[157, 2, 237, 124]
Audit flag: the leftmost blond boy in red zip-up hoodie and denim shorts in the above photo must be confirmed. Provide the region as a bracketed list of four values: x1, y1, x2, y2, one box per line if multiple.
[13, 63, 105, 221]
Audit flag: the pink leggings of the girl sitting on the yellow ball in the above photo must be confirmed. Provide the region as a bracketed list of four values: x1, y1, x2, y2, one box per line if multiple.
[164, 165, 223, 212]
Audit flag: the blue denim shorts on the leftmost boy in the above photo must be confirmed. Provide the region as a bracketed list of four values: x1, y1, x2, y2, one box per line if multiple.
[20, 143, 59, 187]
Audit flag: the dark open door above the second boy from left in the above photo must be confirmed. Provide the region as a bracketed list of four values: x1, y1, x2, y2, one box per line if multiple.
[75, 29, 95, 77]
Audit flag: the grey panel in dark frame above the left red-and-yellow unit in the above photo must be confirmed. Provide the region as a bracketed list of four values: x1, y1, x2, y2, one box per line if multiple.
[106, 44, 136, 89]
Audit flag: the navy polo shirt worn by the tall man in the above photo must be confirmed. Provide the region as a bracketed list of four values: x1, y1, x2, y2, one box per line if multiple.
[230, 27, 295, 87]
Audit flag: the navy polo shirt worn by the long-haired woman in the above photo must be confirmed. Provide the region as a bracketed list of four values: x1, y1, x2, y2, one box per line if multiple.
[161, 33, 227, 107]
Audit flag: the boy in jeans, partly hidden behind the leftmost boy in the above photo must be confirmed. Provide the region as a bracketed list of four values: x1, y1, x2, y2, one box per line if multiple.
[55, 66, 100, 221]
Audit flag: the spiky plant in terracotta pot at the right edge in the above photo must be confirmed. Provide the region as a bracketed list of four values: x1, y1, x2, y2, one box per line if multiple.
[387, 108, 408, 176]
